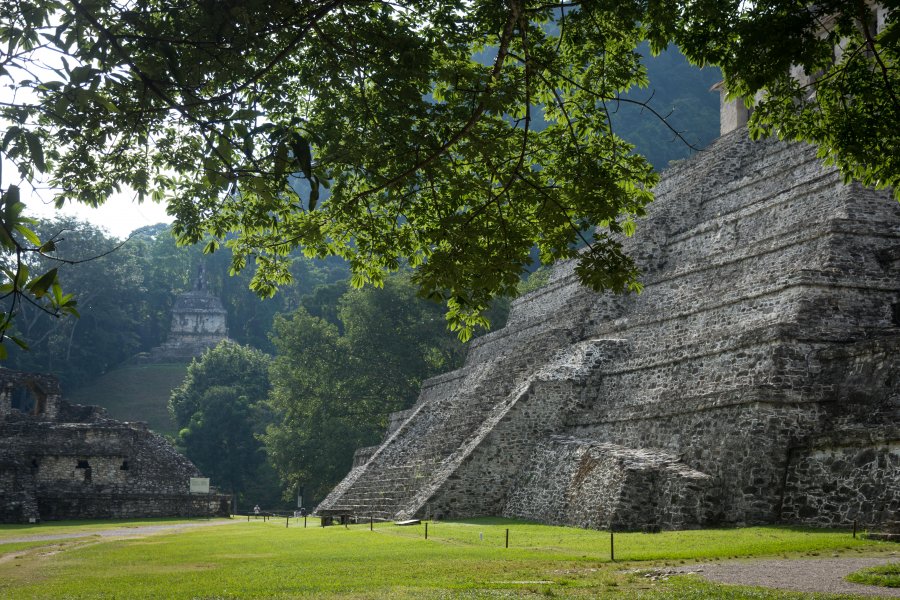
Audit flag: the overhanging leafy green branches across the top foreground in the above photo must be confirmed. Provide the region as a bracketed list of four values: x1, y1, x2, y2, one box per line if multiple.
[0, 0, 900, 346]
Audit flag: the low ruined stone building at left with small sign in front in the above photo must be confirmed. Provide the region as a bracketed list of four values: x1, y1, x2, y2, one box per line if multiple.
[0, 369, 228, 523]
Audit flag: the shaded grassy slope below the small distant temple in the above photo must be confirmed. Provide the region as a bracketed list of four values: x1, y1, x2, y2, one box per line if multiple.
[66, 364, 187, 434]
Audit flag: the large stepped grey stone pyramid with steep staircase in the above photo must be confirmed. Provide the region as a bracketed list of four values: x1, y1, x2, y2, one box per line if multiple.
[317, 109, 900, 529]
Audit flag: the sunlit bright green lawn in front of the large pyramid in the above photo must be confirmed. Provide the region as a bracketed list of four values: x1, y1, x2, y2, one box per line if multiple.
[0, 519, 897, 600]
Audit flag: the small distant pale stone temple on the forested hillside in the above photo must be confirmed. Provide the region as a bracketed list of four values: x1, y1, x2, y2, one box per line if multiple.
[139, 264, 228, 362]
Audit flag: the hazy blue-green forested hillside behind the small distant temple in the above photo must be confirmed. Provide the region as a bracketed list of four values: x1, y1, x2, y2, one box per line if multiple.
[6, 219, 347, 392]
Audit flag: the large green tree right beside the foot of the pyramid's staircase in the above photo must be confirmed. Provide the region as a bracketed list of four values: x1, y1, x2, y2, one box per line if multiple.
[263, 274, 464, 500]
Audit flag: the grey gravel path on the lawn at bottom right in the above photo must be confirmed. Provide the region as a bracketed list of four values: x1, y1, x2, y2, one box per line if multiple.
[670, 555, 900, 598]
